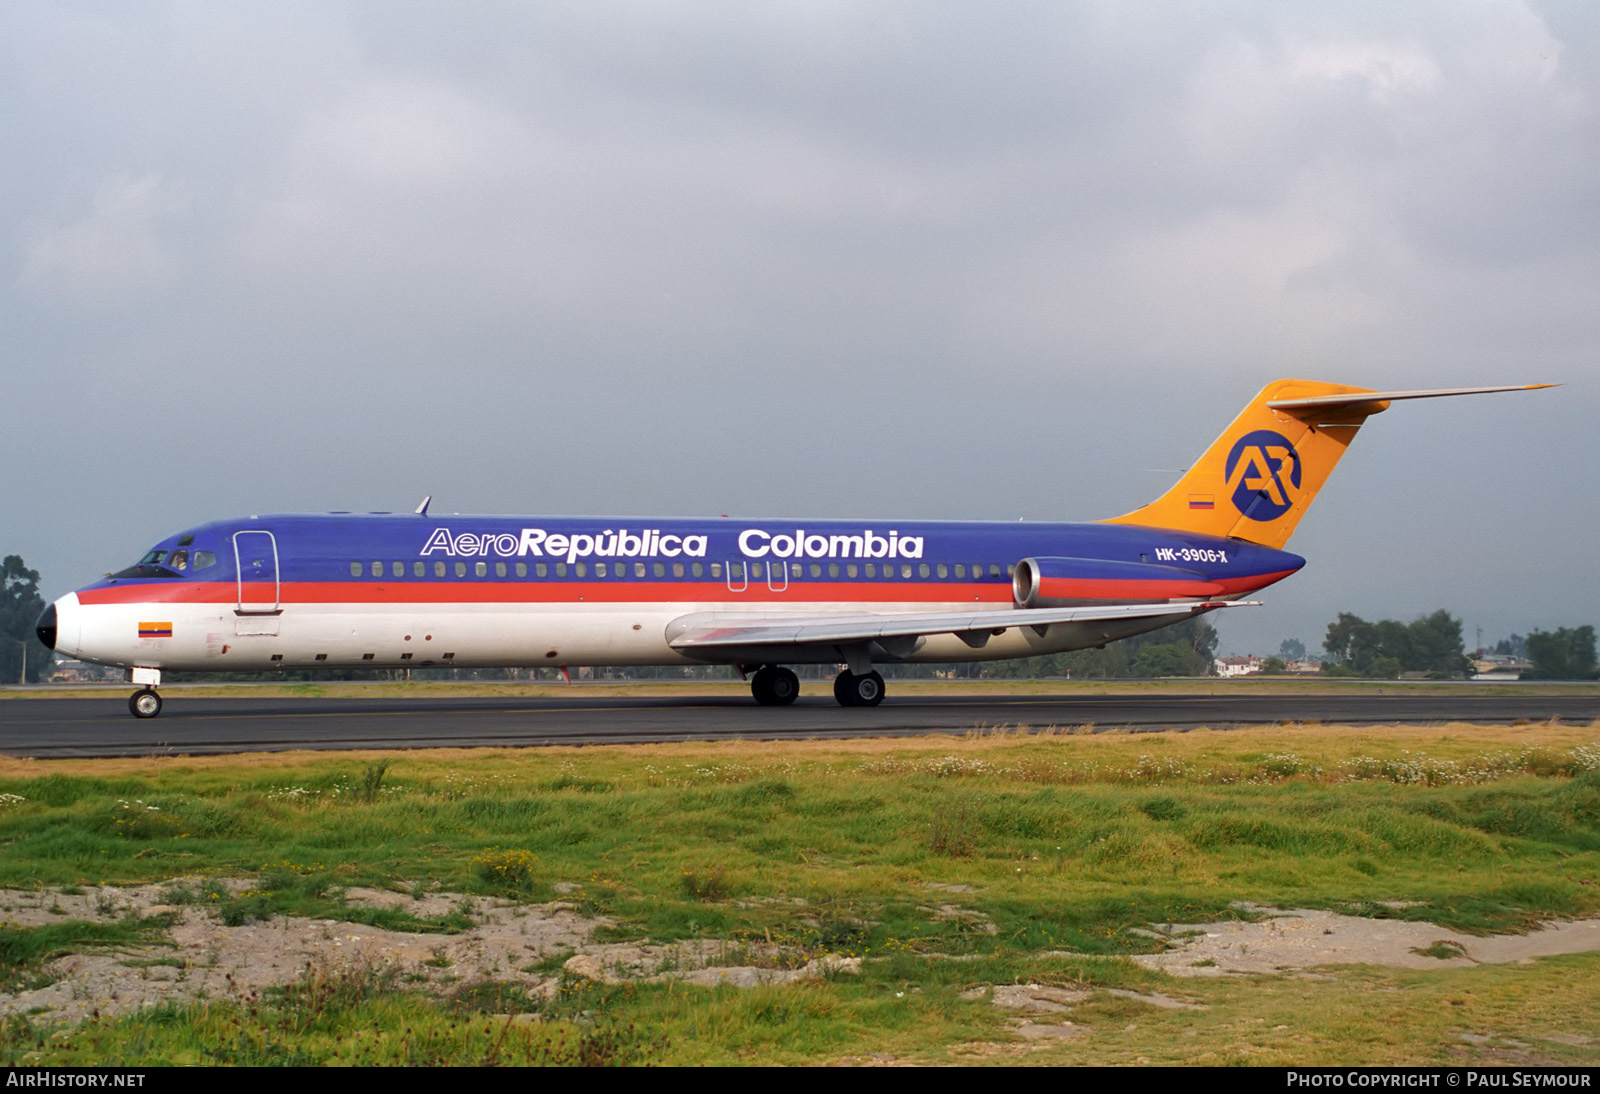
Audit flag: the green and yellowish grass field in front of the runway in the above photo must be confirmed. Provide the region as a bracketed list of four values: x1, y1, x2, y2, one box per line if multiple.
[0, 722, 1600, 1064]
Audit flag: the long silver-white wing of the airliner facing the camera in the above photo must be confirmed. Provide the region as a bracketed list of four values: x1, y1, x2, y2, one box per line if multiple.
[667, 600, 1261, 649]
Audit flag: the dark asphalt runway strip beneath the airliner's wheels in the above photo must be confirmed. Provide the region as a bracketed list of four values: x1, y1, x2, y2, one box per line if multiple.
[0, 686, 1600, 758]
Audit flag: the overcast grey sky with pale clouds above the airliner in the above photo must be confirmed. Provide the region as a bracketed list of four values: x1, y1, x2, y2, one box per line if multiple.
[0, 0, 1600, 653]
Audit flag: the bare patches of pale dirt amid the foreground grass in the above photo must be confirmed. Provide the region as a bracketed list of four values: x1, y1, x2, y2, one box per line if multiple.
[9, 878, 1600, 1038]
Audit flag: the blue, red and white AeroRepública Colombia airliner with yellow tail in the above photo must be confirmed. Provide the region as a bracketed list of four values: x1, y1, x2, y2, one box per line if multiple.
[37, 379, 1550, 718]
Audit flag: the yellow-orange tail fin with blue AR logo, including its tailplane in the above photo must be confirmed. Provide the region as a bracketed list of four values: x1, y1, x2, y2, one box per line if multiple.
[1104, 379, 1552, 547]
